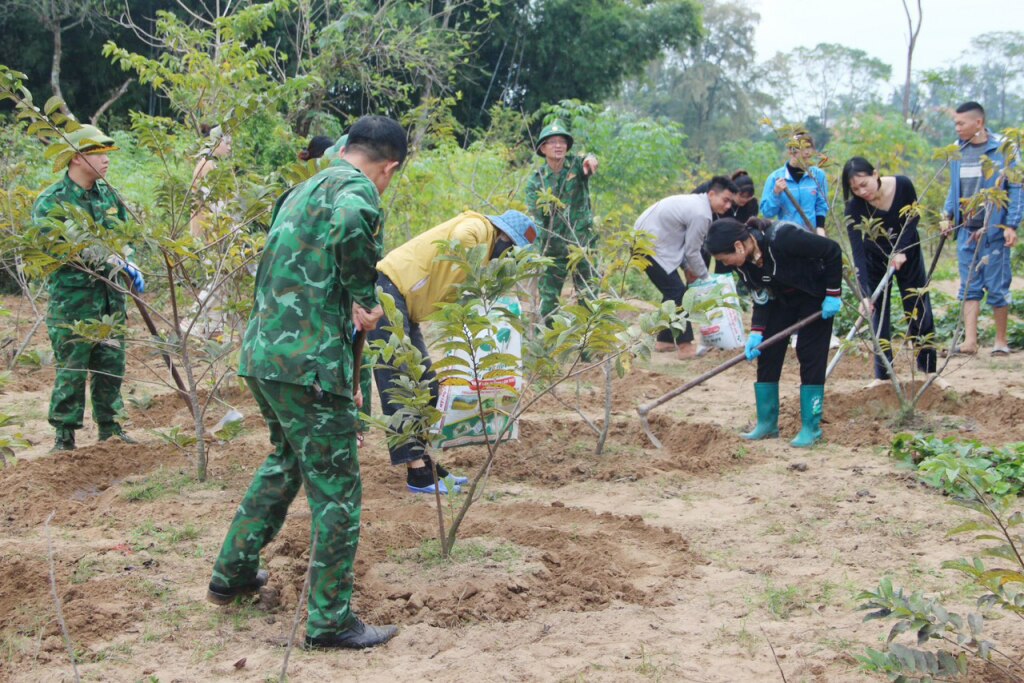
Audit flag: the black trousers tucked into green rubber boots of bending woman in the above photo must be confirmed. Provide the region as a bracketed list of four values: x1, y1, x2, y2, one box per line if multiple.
[758, 291, 835, 385]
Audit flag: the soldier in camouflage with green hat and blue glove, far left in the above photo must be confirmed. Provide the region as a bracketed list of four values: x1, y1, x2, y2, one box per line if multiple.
[32, 126, 145, 452]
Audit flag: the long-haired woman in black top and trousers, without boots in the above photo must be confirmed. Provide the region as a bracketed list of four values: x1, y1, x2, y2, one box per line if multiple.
[843, 157, 946, 387]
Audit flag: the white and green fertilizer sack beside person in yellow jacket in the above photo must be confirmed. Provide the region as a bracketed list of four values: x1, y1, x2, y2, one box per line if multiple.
[434, 296, 522, 449]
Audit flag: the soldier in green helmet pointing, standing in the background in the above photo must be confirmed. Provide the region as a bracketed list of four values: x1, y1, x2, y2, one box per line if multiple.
[526, 121, 597, 319]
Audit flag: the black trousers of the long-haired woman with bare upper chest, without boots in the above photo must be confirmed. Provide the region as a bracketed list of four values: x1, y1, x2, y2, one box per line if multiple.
[862, 247, 938, 380]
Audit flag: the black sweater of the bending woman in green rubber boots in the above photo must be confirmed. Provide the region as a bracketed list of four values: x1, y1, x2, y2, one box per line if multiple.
[737, 222, 843, 332]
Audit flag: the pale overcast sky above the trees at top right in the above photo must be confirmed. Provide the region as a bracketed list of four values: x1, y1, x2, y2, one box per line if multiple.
[745, 0, 1024, 83]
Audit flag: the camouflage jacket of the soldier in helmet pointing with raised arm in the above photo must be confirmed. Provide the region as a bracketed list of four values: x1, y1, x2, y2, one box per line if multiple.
[526, 156, 594, 256]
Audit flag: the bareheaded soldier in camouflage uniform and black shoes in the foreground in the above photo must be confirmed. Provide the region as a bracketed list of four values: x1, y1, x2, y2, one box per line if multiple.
[207, 117, 407, 648]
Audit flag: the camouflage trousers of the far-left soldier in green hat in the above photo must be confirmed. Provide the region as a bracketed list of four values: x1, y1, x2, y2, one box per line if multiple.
[47, 322, 125, 429]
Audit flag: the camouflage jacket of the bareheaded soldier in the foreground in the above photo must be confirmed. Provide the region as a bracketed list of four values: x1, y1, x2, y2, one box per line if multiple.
[239, 161, 381, 396]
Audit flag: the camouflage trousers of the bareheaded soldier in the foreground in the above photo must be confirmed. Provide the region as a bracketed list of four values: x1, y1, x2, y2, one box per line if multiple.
[213, 378, 362, 637]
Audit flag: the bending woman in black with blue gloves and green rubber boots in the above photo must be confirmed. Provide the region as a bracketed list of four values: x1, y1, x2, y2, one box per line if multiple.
[705, 218, 843, 449]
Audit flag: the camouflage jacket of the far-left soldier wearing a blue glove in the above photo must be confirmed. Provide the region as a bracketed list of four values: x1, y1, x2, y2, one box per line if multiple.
[32, 173, 128, 323]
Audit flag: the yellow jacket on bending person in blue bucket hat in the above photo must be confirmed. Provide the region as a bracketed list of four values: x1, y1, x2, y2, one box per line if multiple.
[377, 211, 499, 323]
